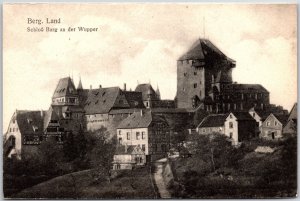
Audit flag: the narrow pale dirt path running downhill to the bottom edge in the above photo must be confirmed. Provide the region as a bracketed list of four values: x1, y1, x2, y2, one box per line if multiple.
[153, 158, 171, 198]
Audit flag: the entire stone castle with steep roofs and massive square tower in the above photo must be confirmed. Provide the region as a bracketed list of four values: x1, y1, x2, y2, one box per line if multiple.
[4, 39, 283, 158]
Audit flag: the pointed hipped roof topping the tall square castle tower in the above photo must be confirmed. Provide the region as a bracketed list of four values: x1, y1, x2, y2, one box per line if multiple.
[178, 39, 235, 63]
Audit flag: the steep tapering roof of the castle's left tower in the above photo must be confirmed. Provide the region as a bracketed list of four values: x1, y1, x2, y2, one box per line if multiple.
[52, 77, 78, 98]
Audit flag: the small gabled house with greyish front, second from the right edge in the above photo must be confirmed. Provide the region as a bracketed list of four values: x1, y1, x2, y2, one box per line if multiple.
[260, 113, 288, 140]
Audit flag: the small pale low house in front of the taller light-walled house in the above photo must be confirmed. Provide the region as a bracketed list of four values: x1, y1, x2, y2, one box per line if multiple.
[112, 144, 146, 170]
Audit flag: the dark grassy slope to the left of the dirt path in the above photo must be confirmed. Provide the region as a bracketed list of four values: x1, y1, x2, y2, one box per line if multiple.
[14, 167, 155, 199]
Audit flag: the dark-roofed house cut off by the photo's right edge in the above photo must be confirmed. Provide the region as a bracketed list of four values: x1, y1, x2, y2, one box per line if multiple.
[282, 103, 297, 137]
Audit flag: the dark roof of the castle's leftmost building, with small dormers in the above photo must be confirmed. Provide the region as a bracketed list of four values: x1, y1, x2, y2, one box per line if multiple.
[16, 111, 46, 135]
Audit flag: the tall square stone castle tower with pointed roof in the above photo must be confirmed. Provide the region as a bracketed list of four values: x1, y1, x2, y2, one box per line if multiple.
[177, 39, 235, 108]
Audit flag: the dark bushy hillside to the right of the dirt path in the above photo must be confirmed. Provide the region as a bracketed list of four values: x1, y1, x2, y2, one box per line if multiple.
[169, 137, 297, 199]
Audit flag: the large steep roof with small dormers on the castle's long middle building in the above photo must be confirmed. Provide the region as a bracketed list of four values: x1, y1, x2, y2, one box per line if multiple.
[84, 87, 130, 114]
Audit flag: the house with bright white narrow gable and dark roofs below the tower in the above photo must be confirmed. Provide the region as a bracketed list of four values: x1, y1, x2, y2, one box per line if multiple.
[197, 112, 257, 145]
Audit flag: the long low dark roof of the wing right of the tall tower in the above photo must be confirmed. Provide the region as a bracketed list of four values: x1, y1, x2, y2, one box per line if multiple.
[223, 84, 269, 93]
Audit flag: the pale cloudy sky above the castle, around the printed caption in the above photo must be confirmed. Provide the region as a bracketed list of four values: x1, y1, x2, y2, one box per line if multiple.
[3, 3, 297, 132]
